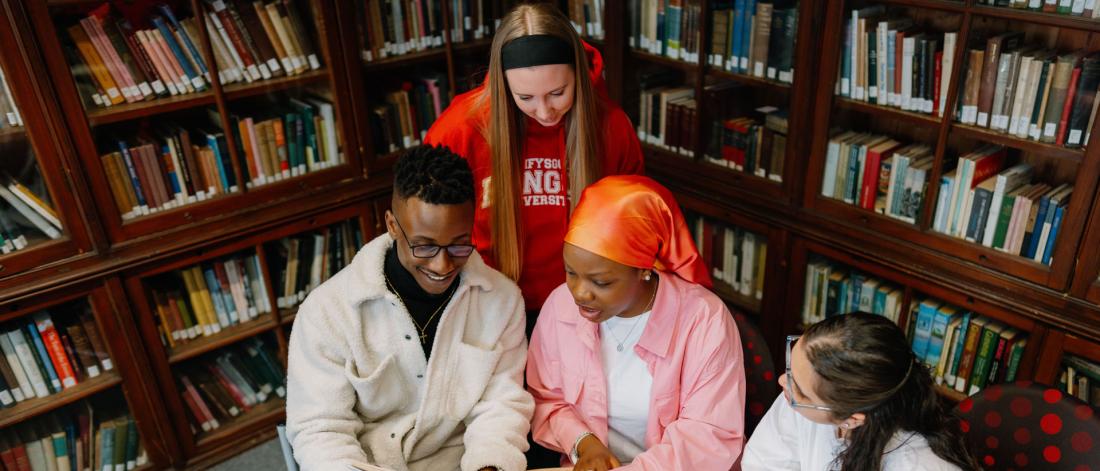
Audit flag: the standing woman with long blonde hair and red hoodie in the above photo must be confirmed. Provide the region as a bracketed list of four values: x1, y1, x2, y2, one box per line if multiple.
[426, 3, 642, 323]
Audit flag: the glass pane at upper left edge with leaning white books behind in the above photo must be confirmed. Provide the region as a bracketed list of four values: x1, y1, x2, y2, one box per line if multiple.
[0, 66, 65, 253]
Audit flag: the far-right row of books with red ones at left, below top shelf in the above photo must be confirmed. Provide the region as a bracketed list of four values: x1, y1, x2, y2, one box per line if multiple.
[933, 145, 1074, 265]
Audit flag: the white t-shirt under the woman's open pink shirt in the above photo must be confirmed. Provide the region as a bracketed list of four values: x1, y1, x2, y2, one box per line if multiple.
[600, 310, 653, 463]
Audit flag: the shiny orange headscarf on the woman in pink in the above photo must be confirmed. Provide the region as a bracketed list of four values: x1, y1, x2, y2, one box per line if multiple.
[565, 175, 713, 287]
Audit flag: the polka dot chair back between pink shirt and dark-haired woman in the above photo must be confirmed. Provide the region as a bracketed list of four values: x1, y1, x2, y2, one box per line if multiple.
[734, 311, 774, 435]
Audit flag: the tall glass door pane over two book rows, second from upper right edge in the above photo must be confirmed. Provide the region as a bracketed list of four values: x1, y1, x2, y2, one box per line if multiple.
[821, 1, 961, 224]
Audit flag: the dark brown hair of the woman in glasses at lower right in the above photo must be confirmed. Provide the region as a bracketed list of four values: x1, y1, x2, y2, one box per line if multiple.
[801, 313, 979, 471]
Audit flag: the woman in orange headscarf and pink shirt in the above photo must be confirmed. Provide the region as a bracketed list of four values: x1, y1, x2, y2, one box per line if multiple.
[527, 176, 745, 471]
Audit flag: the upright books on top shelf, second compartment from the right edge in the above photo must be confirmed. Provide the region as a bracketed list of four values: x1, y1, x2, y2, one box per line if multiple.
[835, 6, 958, 116]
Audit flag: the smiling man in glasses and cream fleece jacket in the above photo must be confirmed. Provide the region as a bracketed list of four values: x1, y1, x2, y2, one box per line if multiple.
[286, 146, 534, 471]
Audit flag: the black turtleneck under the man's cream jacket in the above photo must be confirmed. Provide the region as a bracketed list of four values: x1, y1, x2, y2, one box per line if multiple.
[383, 245, 459, 359]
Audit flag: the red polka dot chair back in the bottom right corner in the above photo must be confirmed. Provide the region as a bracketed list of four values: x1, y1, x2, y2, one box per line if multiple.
[956, 381, 1100, 471]
